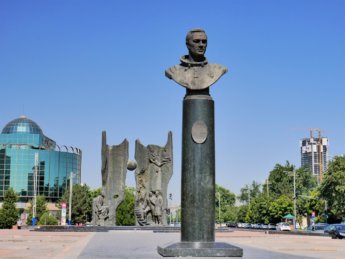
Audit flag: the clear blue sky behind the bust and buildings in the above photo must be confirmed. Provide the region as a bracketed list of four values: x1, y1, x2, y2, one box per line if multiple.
[0, 0, 345, 202]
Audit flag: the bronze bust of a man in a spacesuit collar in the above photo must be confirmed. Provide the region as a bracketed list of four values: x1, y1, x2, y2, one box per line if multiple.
[165, 29, 228, 90]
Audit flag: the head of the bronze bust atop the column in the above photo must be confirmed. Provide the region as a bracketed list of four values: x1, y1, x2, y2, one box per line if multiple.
[186, 29, 207, 62]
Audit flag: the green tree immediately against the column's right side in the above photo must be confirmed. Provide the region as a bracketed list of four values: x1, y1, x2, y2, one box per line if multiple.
[215, 184, 236, 222]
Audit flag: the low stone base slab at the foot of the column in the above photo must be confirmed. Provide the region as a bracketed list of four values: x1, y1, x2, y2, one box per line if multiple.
[157, 242, 243, 257]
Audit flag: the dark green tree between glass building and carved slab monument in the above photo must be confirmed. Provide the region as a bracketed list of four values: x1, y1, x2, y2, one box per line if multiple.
[57, 184, 92, 224]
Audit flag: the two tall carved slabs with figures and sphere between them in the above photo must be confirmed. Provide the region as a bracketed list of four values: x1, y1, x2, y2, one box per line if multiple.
[92, 131, 173, 226]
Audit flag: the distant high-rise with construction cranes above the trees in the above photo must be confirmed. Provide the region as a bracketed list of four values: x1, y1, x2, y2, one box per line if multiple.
[300, 137, 328, 183]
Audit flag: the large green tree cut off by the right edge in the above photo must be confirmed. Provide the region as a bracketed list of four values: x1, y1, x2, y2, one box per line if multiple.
[320, 156, 345, 222]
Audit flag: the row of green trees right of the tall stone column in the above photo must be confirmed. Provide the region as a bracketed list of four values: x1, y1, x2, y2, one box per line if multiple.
[215, 156, 345, 225]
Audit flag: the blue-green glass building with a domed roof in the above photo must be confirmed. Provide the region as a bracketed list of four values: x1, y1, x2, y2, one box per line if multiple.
[0, 116, 82, 202]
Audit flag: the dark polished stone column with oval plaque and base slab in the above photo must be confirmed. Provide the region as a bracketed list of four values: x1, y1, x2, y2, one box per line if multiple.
[158, 89, 243, 257]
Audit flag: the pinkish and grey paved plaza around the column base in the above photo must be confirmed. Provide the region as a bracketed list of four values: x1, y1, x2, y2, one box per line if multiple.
[0, 230, 345, 259]
